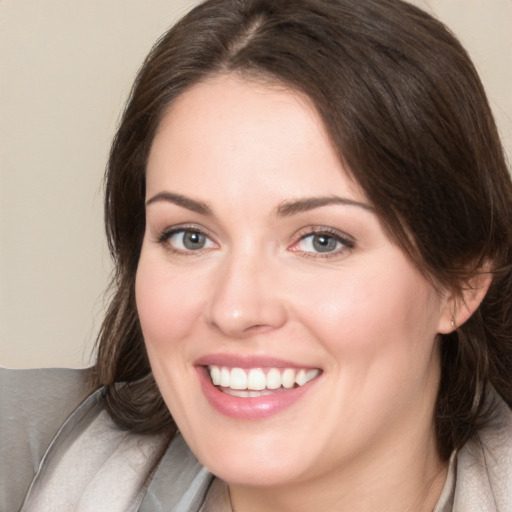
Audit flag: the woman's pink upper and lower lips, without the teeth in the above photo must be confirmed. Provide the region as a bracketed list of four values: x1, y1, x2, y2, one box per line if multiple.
[196, 355, 318, 420]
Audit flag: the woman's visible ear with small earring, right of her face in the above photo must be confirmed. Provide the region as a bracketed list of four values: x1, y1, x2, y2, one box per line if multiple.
[437, 265, 493, 334]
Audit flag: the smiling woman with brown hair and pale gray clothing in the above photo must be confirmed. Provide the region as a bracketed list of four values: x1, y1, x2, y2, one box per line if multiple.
[2, 0, 512, 512]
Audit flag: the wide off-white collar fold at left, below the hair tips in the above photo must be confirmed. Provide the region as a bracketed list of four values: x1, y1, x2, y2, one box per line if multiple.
[21, 392, 168, 512]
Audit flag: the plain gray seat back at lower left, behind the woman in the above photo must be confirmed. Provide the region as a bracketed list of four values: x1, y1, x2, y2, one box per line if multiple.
[0, 368, 88, 510]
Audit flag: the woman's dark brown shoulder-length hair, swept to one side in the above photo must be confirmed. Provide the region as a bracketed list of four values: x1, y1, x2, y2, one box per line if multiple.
[95, 0, 512, 457]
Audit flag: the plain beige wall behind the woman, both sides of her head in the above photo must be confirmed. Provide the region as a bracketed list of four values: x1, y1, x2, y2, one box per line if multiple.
[0, 0, 512, 367]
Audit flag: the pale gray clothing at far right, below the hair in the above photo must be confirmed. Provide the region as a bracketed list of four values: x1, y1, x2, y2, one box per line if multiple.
[454, 397, 512, 511]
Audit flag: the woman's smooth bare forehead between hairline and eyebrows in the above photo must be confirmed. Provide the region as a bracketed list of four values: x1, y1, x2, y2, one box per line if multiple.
[147, 75, 363, 204]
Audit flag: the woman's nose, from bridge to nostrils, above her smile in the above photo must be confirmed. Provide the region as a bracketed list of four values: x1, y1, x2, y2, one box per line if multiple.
[206, 250, 287, 338]
